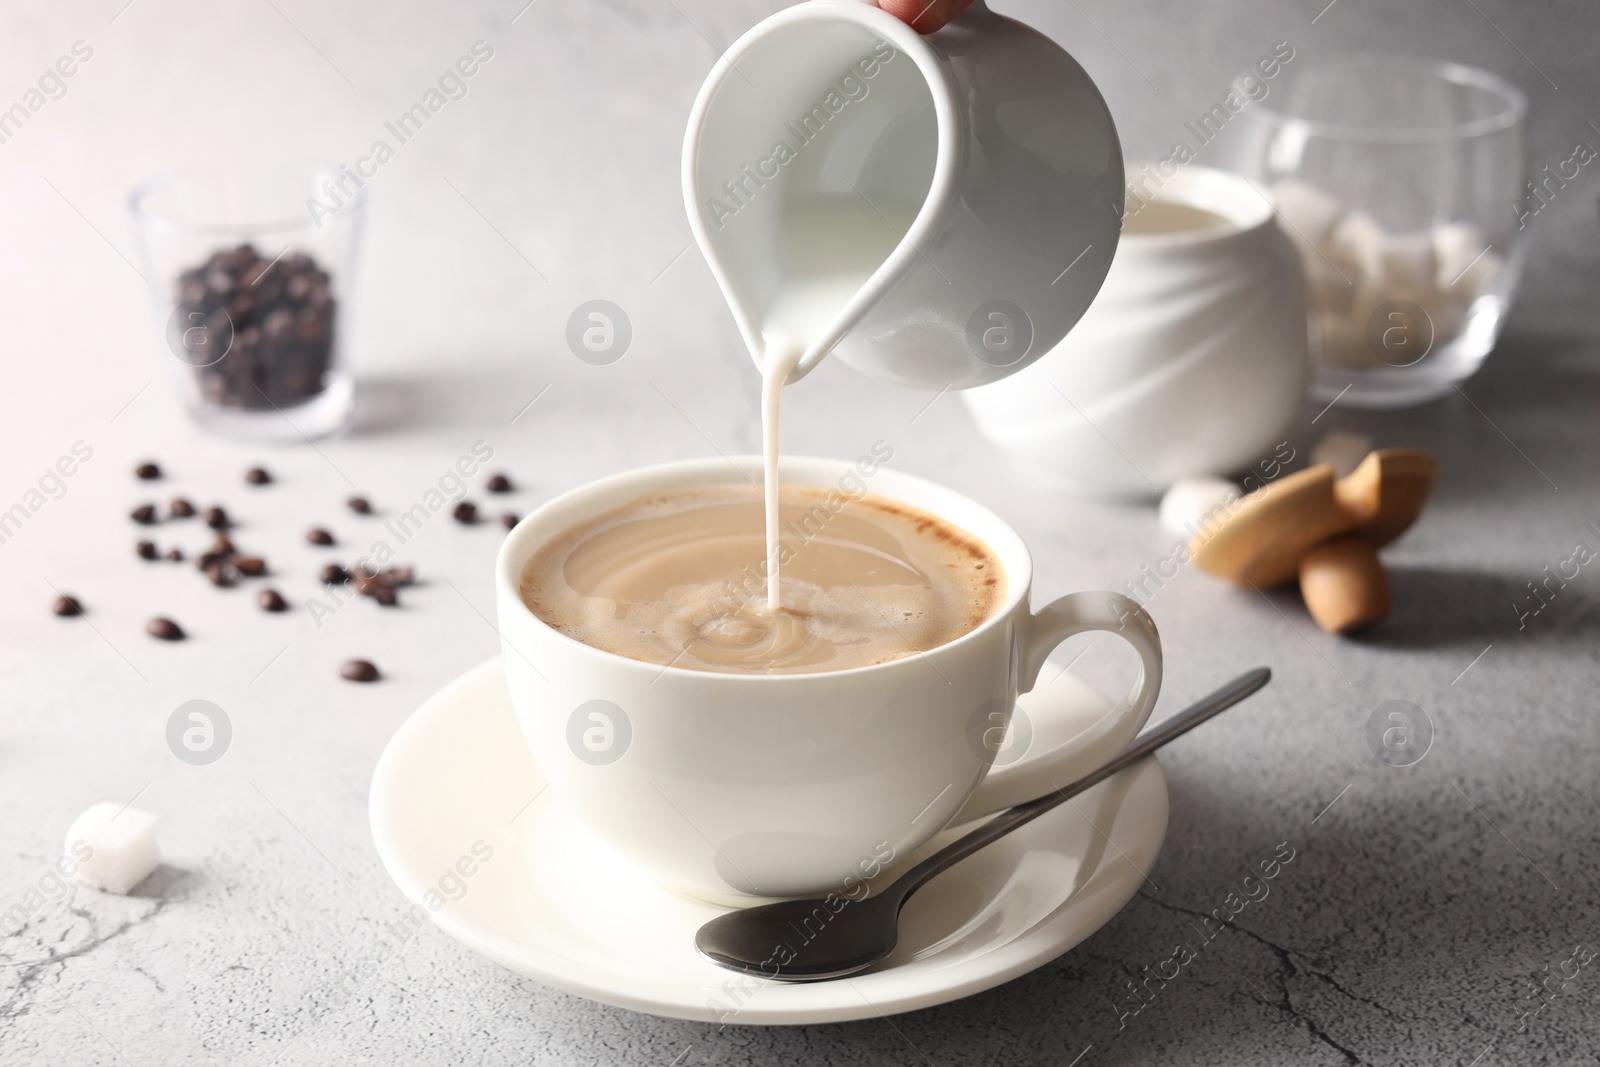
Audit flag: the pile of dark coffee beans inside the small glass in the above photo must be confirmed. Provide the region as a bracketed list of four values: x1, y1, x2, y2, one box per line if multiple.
[178, 245, 338, 411]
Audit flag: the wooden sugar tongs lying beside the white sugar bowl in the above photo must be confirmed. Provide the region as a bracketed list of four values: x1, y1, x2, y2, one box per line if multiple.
[1189, 448, 1438, 633]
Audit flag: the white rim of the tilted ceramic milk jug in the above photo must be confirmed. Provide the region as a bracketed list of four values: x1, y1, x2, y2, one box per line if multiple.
[680, 0, 960, 384]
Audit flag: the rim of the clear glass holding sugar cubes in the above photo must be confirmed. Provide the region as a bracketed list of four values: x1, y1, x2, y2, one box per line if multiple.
[1234, 51, 1528, 144]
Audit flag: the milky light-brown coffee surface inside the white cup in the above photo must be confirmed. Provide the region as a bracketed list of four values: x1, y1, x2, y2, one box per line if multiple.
[522, 486, 1005, 673]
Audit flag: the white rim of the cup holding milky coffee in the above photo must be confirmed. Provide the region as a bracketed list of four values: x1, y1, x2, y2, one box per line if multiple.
[494, 454, 1034, 686]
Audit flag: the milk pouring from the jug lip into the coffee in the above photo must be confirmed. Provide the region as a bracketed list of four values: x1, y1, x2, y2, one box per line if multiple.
[752, 198, 915, 611]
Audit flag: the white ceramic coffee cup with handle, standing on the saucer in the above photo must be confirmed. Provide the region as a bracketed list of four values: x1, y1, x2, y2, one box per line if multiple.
[496, 456, 1162, 904]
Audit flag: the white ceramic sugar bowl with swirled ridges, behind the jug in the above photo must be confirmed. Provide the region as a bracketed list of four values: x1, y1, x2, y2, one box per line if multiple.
[962, 165, 1310, 498]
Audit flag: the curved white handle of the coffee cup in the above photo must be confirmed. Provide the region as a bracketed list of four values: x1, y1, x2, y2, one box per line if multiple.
[950, 592, 1162, 824]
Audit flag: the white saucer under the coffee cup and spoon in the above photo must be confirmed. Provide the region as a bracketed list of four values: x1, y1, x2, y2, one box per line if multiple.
[371, 657, 1166, 1025]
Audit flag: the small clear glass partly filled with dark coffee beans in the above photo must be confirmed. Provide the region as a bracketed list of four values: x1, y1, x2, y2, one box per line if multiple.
[128, 166, 366, 442]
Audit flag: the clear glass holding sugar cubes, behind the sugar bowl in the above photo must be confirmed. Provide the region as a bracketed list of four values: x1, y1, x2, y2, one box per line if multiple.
[1218, 54, 1539, 408]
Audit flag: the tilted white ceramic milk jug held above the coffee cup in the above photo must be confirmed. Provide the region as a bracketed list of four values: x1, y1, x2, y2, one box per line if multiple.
[683, 0, 1123, 389]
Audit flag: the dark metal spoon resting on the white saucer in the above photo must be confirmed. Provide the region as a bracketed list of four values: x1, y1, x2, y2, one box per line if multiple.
[694, 667, 1272, 982]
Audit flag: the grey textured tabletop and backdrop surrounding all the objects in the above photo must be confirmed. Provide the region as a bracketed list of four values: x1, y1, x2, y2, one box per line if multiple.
[0, 0, 1600, 1067]
